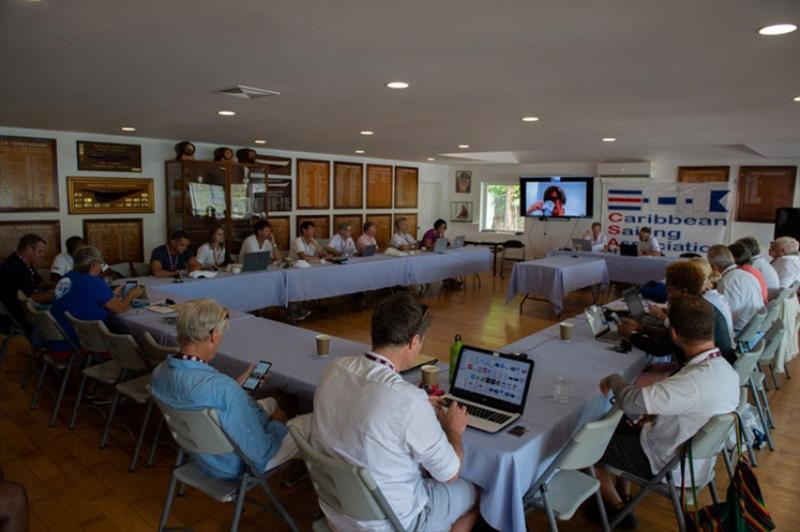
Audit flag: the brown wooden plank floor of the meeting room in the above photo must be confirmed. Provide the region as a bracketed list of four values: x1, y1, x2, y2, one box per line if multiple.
[0, 274, 800, 532]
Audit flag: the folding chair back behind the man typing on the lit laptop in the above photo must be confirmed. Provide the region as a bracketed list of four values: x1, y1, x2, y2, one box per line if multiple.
[289, 425, 405, 532]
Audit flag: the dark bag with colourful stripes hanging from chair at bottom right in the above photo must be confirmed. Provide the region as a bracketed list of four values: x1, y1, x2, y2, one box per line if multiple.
[681, 413, 775, 532]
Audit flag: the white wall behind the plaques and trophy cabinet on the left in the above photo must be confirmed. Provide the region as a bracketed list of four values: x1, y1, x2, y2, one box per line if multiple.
[0, 126, 449, 259]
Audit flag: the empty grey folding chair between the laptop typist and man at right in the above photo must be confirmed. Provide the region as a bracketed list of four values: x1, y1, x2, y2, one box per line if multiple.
[524, 408, 622, 532]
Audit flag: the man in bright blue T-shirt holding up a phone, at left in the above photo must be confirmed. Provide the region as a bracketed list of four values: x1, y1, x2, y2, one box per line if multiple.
[50, 246, 144, 358]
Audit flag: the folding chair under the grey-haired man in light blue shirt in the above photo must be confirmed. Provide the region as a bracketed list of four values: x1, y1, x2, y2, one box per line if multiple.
[153, 398, 299, 532]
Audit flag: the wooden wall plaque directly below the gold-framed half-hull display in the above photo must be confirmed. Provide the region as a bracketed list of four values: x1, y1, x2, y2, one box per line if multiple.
[83, 218, 144, 264]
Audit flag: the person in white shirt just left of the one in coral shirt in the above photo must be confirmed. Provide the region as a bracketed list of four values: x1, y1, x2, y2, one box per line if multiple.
[708, 244, 764, 334]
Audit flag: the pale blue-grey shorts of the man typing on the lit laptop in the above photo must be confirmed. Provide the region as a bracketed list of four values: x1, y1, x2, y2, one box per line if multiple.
[409, 478, 478, 532]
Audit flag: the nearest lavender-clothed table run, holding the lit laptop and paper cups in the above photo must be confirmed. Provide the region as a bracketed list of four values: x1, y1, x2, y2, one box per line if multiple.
[112, 294, 646, 531]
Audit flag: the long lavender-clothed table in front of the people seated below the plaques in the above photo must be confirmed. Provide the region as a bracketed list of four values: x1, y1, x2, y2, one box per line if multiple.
[134, 248, 491, 311]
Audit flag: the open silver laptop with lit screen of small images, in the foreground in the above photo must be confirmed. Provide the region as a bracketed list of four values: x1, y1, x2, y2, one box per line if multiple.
[444, 345, 533, 434]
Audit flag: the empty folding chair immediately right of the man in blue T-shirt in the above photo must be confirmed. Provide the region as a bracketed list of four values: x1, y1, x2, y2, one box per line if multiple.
[64, 311, 122, 430]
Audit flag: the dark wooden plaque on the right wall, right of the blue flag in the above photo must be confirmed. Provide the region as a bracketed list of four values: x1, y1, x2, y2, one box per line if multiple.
[736, 166, 797, 223]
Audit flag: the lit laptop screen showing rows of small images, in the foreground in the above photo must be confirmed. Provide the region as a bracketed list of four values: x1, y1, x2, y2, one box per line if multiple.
[452, 346, 533, 412]
